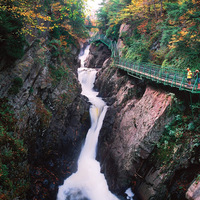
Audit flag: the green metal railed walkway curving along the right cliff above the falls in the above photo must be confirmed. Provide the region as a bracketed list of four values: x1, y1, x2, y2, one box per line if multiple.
[90, 35, 200, 94]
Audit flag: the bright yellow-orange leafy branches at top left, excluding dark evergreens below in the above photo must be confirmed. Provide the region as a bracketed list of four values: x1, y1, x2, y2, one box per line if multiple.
[0, 0, 88, 38]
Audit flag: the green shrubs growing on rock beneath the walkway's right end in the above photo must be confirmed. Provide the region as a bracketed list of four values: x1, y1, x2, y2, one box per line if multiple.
[154, 98, 200, 164]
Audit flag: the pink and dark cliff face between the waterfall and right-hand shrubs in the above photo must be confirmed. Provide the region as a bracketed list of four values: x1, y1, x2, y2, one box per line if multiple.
[96, 59, 171, 195]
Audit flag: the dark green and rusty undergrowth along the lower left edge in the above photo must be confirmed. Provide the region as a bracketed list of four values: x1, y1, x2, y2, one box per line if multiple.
[0, 98, 29, 200]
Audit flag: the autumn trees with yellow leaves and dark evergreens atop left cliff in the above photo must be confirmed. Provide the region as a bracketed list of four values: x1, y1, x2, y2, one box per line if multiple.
[0, 0, 88, 66]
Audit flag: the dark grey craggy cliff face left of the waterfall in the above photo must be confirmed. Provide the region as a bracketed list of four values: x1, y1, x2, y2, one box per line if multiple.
[0, 38, 90, 199]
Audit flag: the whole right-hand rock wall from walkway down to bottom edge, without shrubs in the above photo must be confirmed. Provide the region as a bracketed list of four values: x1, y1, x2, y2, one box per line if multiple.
[95, 54, 200, 200]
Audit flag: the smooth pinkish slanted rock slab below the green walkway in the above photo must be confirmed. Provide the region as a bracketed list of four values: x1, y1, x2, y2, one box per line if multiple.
[99, 87, 171, 191]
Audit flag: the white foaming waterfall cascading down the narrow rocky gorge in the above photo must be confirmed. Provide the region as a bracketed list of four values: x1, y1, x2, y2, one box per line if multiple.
[57, 47, 118, 200]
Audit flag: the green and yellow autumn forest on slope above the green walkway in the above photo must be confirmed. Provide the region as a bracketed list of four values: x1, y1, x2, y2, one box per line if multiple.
[97, 0, 200, 70]
